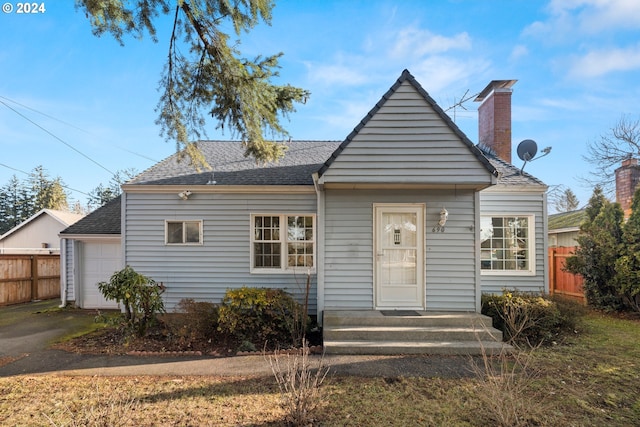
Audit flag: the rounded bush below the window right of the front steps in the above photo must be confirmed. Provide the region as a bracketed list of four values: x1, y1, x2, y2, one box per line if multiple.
[482, 290, 581, 347]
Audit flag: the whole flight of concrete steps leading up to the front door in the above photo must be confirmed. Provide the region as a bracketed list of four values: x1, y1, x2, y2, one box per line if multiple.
[323, 310, 510, 355]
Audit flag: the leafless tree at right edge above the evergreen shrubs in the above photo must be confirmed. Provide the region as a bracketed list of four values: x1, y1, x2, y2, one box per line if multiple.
[584, 115, 640, 193]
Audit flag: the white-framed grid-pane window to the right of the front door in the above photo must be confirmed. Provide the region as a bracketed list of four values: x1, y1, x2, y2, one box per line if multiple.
[480, 216, 535, 274]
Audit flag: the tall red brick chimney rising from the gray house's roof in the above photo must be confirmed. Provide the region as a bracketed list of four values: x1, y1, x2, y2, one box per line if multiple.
[474, 80, 517, 163]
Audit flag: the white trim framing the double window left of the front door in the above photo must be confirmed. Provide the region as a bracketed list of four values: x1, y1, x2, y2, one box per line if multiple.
[249, 212, 318, 274]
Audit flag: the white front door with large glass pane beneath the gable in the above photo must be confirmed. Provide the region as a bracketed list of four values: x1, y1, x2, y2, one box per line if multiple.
[374, 204, 425, 310]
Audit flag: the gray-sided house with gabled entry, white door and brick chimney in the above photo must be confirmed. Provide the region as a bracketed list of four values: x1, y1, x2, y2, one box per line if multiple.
[61, 71, 548, 320]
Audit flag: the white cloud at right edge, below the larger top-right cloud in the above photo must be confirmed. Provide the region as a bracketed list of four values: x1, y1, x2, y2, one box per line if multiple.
[569, 45, 640, 78]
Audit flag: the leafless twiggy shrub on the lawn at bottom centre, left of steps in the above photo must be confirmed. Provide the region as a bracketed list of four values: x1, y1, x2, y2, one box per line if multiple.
[268, 341, 329, 426]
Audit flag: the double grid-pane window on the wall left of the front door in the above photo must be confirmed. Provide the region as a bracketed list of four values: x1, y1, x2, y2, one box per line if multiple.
[251, 215, 315, 272]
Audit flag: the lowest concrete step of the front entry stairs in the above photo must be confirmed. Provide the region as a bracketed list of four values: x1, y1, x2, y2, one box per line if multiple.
[323, 341, 512, 356]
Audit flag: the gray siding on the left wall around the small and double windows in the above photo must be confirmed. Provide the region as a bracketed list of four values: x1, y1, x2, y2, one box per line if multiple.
[123, 189, 317, 313]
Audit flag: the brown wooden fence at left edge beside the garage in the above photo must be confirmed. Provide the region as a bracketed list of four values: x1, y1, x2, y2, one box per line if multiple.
[0, 255, 60, 306]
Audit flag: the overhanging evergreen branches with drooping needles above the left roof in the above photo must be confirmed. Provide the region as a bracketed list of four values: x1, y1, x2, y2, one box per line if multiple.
[76, 0, 309, 167]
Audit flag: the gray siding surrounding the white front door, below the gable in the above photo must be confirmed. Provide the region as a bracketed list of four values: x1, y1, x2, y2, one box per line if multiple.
[324, 190, 476, 311]
